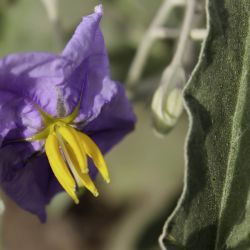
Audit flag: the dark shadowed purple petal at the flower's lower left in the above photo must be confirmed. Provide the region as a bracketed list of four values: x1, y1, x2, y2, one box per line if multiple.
[0, 143, 62, 221]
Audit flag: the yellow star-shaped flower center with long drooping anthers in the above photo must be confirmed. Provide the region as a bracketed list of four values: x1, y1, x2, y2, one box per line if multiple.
[26, 105, 110, 203]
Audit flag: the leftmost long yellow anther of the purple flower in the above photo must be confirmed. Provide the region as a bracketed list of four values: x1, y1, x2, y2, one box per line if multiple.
[45, 133, 79, 203]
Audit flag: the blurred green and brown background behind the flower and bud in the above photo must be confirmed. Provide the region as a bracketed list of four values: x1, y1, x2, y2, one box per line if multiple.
[0, 0, 205, 250]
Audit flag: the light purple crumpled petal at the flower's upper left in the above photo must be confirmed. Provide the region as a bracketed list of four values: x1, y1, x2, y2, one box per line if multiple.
[0, 53, 67, 145]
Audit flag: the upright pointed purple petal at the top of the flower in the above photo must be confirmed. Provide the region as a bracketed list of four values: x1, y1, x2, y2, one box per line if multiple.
[62, 6, 113, 121]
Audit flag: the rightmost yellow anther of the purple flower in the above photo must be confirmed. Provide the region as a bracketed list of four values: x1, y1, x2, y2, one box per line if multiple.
[77, 132, 110, 183]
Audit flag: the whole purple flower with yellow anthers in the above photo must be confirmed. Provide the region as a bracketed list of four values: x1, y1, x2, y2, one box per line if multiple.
[0, 6, 135, 221]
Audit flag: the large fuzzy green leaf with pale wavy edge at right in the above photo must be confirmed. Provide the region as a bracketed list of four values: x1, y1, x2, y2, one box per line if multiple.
[160, 0, 250, 250]
